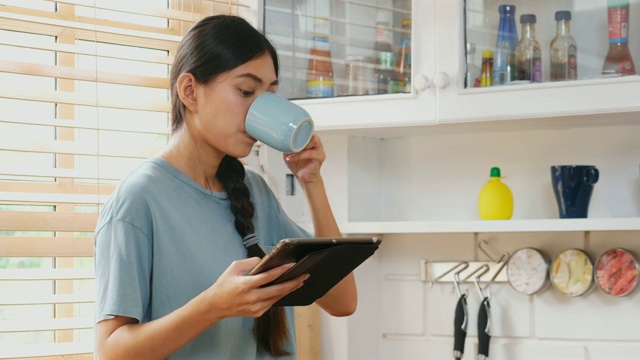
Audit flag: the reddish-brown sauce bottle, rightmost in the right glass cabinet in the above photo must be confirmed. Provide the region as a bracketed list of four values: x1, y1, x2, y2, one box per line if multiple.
[602, 0, 636, 75]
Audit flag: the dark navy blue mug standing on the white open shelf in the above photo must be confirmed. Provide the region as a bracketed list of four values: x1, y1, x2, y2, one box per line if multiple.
[551, 165, 600, 219]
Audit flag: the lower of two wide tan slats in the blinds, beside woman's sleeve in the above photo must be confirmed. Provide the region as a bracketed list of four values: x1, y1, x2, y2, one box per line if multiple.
[0, 236, 93, 257]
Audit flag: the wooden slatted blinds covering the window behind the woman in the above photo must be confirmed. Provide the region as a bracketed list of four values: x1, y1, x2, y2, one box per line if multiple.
[0, 0, 252, 359]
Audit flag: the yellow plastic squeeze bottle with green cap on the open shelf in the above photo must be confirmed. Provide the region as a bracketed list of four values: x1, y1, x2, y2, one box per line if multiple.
[478, 167, 513, 220]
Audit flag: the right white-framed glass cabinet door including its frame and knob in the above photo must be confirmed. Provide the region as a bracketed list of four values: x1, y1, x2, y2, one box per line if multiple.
[435, 0, 640, 123]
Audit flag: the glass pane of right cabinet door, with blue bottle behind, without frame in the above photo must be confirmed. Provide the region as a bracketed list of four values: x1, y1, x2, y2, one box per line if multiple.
[465, 0, 640, 88]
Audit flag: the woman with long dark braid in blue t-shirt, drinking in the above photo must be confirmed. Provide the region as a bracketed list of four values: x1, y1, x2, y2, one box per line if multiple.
[96, 16, 357, 360]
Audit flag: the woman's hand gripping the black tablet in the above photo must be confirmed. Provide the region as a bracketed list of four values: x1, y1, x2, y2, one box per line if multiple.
[205, 257, 309, 320]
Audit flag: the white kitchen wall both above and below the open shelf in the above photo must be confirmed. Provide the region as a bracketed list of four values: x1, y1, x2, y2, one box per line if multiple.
[314, 117, 640, 360]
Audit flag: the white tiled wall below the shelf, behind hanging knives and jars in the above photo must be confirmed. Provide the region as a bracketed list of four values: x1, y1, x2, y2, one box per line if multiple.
[326, 231, 640, 360]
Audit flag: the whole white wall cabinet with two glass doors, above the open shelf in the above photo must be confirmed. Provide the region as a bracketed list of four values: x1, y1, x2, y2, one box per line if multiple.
[265, 0, 640, 129]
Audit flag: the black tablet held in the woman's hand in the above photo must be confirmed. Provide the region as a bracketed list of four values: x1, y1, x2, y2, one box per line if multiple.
[247, 237, 382, 306]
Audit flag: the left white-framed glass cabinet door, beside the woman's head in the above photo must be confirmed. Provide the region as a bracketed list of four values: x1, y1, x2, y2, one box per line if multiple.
[262, 0, 436, 130]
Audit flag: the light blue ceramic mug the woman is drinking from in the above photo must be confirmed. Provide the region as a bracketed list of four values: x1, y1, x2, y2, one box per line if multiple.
[245, 92, 314, 153]
